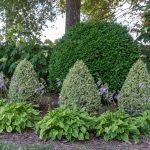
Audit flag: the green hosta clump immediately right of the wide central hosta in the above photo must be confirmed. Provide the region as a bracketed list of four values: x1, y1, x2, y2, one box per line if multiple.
[95, 110, 140, 142]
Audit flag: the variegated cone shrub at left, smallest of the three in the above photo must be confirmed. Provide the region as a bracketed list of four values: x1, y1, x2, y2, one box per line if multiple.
[8, 60, 39, 101]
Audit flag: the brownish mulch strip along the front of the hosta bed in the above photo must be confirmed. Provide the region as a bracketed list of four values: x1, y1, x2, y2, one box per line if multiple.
[0, 130, 150, 150]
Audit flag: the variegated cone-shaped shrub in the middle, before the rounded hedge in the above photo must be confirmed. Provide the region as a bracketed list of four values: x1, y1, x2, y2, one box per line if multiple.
[60, 60, 101, 112]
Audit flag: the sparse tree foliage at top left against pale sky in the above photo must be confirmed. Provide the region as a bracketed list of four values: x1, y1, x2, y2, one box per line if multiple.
[0, 0, 57, 41]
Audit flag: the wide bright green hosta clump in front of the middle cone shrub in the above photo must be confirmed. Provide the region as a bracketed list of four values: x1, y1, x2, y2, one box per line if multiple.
[36, 107, 94, 140]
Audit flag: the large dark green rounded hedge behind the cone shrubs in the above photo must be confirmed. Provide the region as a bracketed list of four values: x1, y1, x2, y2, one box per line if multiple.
[49, 22, 139, 90]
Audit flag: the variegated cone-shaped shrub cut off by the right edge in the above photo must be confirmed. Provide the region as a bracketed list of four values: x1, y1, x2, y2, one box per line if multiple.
[119, 58, 150, 115]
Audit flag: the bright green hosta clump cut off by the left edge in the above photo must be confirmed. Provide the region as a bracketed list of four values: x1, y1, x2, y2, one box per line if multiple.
[0, 102, 40, 133]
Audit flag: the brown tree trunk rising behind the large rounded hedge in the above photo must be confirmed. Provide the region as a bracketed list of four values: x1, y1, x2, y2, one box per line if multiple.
[65, 0, 81, 32]
